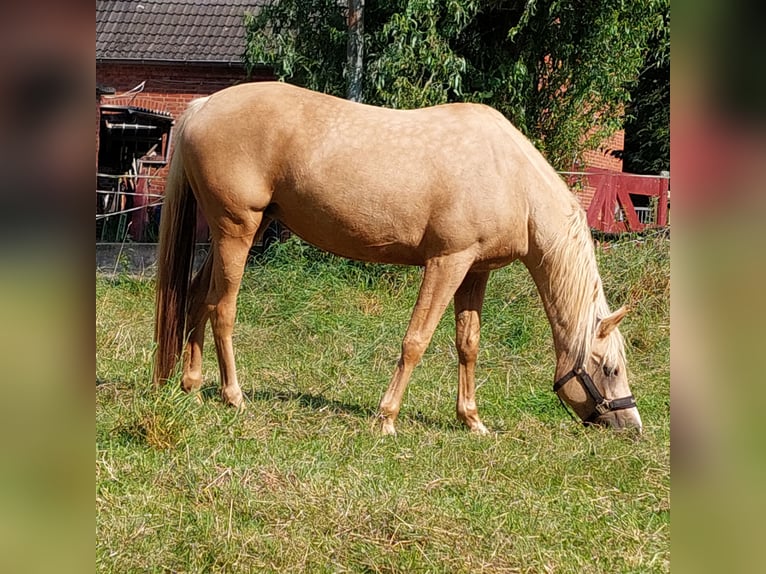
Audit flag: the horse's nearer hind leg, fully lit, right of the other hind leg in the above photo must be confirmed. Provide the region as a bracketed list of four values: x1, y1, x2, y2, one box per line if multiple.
[207, 223, 260, 407]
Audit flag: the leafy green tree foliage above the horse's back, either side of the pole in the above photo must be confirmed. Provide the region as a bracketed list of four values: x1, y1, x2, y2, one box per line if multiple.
[245, 0, 668, 169]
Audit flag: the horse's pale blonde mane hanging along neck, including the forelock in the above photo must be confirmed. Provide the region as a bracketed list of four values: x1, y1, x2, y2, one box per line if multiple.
[543, 207, 625, 365]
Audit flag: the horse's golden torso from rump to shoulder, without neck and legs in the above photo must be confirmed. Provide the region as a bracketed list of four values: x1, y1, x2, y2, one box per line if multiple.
[183, 82, 560, 264]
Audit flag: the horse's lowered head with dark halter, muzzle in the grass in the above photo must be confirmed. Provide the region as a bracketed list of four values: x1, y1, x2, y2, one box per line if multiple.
[553, 307, 641, 431]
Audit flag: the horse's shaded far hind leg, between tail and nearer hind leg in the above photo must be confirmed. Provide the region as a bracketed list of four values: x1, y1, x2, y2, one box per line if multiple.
[181, 253, 213, 400]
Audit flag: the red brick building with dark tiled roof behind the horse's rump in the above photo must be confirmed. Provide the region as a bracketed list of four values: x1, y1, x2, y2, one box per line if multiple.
[96, 0, 274, 241]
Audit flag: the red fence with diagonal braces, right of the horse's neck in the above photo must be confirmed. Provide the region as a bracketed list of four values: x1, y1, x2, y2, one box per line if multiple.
[568, 169, 670, 233]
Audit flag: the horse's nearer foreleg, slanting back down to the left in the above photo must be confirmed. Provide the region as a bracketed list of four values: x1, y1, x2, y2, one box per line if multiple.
[379, 253, 473, 434]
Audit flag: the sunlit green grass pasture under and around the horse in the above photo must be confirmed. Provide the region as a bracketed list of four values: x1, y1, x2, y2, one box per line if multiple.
[96, 234, 670, 574]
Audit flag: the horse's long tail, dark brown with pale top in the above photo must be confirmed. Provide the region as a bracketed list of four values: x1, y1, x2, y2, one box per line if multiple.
[152, 98, 207, 385]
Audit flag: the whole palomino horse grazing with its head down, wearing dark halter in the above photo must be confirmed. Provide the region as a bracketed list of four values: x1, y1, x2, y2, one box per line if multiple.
[154, 83, 641, 434]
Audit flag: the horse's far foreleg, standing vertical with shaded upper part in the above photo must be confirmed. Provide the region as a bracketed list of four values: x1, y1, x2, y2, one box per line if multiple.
[455, 272, 489, 434]
